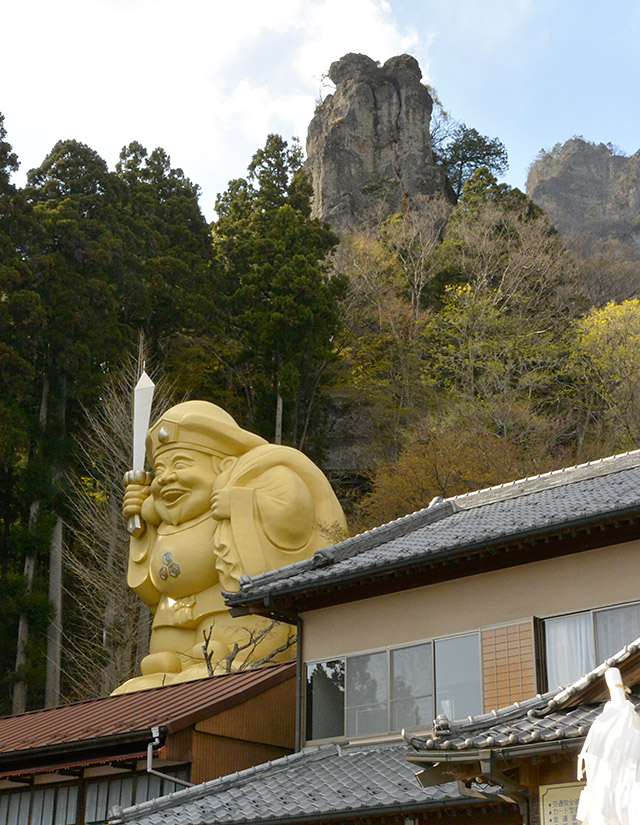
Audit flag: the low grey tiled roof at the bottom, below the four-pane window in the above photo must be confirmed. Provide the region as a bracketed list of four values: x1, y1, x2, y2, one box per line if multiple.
[110, 744, 504, 825]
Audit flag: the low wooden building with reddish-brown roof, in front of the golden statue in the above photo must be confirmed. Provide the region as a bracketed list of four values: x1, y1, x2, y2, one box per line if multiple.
[0, 663, 295, 825]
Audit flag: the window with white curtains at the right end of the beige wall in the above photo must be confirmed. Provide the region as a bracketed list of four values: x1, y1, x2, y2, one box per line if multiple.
[544, 603, 640, 689]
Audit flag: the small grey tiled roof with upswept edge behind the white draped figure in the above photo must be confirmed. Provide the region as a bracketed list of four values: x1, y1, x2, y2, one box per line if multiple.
[405, 638, 640, 759]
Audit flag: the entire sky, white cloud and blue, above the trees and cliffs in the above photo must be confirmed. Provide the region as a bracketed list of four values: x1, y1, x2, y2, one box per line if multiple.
[0, 0, 640, 219]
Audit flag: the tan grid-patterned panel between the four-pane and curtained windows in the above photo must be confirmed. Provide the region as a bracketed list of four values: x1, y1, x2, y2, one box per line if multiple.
[481, 621, 536, 713]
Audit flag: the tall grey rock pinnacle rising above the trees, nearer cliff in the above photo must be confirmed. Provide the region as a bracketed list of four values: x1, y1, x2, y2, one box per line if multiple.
[306, 54, 446, 231]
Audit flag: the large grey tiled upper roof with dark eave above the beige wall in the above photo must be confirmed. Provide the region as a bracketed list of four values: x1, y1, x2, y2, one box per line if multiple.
[226, 450, 640, 620]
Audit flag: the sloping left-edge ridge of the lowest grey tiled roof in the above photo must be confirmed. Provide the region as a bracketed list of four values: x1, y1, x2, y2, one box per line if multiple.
[114, 742, 341, 825]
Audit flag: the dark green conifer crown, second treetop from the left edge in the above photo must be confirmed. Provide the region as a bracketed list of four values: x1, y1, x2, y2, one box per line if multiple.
[26, 141, 122, 402]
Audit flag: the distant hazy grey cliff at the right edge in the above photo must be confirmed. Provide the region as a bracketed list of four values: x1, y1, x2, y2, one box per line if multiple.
[527, 138, 640, 252]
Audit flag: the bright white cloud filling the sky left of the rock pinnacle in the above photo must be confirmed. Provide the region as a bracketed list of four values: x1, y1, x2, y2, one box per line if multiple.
[0, 0, 424, 213]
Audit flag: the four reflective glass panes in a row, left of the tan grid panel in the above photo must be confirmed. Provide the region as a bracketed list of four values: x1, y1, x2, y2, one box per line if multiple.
[306, 633, 481, 740]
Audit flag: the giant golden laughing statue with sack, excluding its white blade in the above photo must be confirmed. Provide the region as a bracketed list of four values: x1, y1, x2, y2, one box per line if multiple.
[115, 394, 346, 693]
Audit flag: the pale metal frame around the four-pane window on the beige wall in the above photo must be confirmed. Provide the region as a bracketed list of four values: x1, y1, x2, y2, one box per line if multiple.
[301, 628, 484, 745]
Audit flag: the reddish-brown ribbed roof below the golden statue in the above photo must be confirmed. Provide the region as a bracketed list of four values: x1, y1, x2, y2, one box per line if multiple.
[0, 662, 295, 756]
